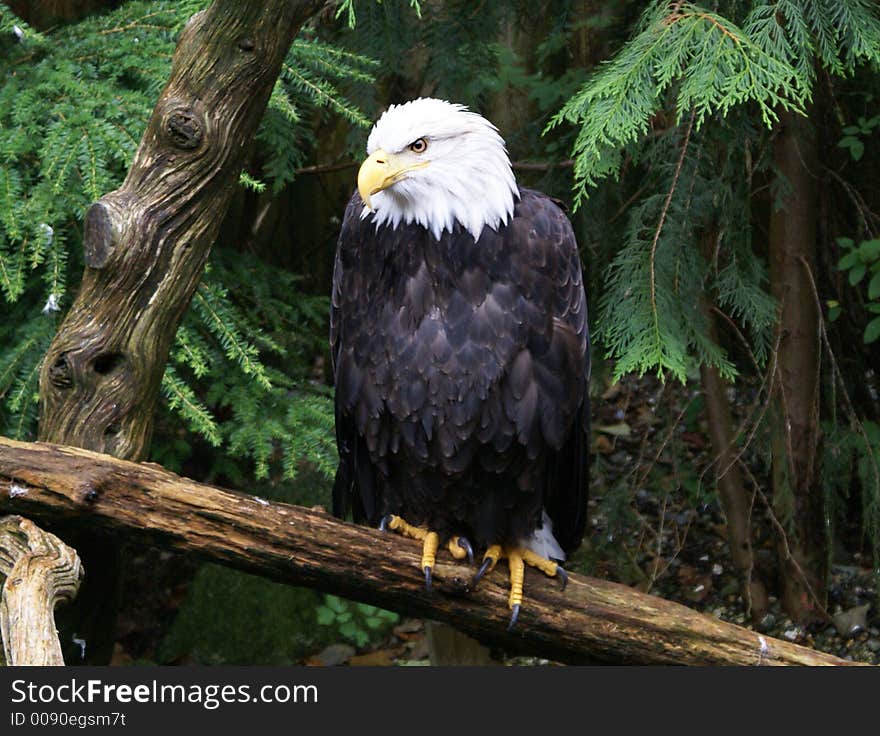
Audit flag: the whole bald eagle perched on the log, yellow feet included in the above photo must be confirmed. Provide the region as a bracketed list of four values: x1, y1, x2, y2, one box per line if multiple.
[330, 98, 590, 626]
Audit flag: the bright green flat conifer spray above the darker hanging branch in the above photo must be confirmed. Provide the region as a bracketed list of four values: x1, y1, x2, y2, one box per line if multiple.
[547, 2, 805, 205]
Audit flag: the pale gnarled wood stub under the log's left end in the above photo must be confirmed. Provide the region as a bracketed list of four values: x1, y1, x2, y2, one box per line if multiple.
[0, 516, 83, 666]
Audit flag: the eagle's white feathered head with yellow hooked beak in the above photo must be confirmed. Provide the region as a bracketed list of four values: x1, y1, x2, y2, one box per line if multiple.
[358, 97, 519, 240]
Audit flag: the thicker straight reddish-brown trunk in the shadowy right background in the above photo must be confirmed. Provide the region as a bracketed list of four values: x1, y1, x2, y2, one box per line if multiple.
[769, 113, 827, 622]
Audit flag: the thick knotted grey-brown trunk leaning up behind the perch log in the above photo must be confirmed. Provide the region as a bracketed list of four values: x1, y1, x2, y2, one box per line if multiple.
[33, 0, 321, 663]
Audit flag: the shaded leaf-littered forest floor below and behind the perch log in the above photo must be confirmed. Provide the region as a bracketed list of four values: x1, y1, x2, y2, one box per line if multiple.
[106, 377, 880, 666]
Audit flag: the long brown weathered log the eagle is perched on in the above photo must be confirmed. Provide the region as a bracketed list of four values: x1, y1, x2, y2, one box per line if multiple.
[0, 438, 864, 665]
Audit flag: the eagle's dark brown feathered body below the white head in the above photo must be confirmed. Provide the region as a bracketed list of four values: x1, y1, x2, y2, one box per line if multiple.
[331, 189, 590, 551]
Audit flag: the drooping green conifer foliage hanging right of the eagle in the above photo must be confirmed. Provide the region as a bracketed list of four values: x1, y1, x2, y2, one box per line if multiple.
[548, 0, 880, 380]
